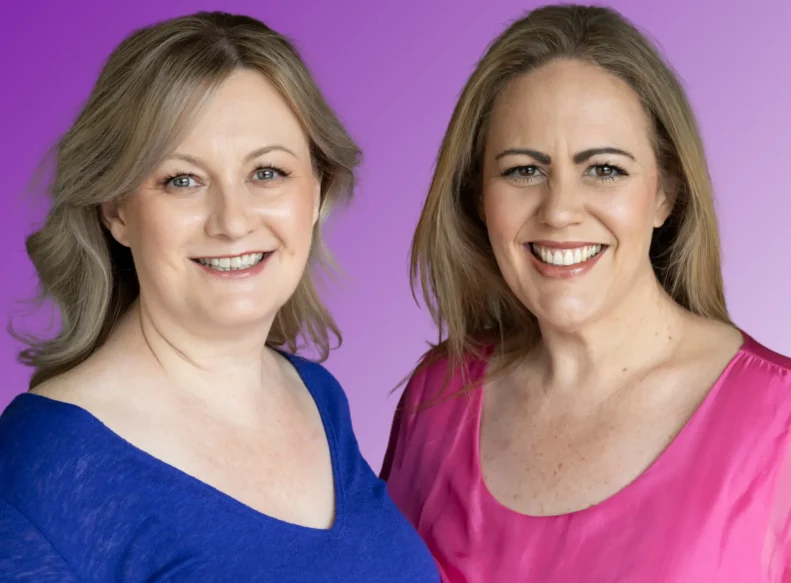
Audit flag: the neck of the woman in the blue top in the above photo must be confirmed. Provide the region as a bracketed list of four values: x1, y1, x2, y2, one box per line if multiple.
[114, 298, 281, 420]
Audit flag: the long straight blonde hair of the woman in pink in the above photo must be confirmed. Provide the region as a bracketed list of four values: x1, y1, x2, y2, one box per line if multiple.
[410, 5, 730, 388]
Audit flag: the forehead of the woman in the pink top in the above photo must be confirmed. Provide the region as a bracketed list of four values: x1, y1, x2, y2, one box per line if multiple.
[487, 60, 652, 150]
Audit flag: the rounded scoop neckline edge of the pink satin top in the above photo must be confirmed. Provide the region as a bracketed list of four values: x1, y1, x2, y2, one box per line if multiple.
[472, 330, 755, 521]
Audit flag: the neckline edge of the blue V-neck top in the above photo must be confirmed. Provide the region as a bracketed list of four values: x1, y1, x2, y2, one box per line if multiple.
[15, 351, 346, 538]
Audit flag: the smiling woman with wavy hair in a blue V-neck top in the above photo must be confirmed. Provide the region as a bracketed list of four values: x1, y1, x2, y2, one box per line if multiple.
[0, 13, 438, 583]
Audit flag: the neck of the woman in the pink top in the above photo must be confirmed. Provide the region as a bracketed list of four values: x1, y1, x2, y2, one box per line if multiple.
[535, 272, 685, 391]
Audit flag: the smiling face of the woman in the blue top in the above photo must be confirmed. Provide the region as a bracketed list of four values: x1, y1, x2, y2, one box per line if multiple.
[103, 71, 320, 329]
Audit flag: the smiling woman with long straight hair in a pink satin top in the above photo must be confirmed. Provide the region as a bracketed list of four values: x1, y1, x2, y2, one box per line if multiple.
[383, 6, 791, 583]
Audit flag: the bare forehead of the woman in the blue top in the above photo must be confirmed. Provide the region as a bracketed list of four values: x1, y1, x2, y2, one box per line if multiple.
[176, 70, 308, 154]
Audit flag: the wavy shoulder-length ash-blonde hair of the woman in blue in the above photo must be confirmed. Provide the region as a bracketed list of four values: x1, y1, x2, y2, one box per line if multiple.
[15, 12, 360, 388]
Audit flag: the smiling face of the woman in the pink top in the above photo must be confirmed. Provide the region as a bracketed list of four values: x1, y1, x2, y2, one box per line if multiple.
[481, 60, 672, 331]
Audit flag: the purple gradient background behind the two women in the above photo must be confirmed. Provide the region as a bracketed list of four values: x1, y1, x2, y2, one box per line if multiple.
[0, 0, 791, 467]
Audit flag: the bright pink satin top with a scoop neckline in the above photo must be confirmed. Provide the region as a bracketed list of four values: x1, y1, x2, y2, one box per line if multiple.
[384, 337, 791, 583]
